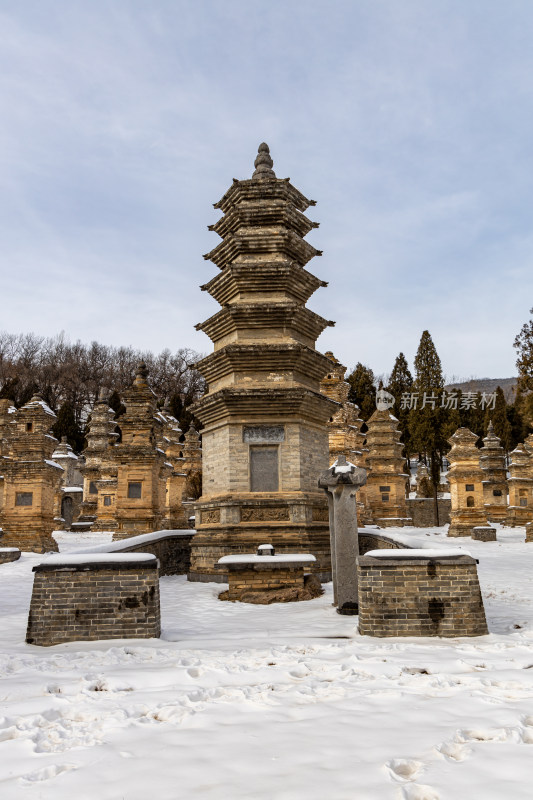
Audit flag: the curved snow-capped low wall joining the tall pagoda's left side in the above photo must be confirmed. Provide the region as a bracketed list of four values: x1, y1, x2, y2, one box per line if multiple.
[77, 528, 196, 577]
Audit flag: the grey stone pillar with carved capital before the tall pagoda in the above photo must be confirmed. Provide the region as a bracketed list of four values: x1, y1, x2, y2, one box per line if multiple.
[318, 455, 366, 614]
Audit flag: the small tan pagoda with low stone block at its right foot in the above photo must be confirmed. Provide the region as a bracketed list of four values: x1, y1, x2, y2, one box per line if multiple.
[447, 428, 487, 536]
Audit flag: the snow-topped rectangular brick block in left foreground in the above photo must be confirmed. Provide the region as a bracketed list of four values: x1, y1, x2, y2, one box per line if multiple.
[26, 553, 161, 647]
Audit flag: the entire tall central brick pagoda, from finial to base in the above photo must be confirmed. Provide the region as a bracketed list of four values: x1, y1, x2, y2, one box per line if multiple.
[189, 144, 338, 580]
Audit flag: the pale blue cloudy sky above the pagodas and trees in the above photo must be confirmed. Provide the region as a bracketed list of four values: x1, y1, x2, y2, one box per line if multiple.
[0, 0, 533, 377]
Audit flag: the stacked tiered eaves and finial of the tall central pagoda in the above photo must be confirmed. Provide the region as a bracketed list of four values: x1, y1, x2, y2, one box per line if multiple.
[192, 144, 336, 432]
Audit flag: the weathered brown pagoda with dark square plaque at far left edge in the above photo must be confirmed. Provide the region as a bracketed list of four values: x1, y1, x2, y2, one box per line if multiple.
[0, 394, 63, 553]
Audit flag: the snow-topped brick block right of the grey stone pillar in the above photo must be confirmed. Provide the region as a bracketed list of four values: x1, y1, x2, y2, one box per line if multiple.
[358, 548, 488, 637]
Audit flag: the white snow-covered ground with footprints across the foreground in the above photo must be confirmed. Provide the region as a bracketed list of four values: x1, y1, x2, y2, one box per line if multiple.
[0, 528, 533, 800]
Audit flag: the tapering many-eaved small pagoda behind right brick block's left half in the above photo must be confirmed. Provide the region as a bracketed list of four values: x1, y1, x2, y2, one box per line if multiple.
[364, 408, 412, 528]
